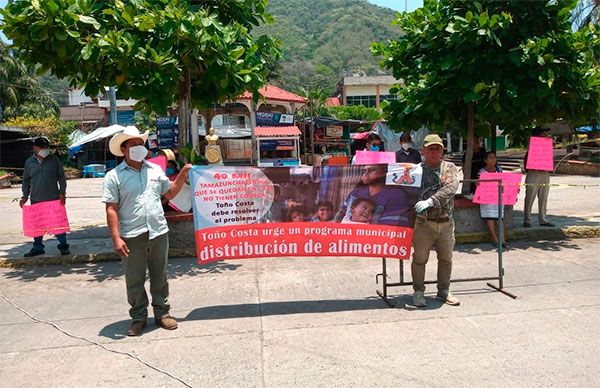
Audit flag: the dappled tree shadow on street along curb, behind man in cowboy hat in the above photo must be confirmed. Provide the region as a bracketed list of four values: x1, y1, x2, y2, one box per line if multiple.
[4, 259, 241, 282]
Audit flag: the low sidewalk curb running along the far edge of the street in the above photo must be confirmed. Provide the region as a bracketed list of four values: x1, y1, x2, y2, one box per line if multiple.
[0, 225, 600, 268]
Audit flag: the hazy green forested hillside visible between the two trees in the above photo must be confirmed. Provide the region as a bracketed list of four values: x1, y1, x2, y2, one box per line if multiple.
[256, 0, 398, 92]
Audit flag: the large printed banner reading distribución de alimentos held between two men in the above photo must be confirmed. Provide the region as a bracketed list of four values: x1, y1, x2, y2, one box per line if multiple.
[190, 164, 420, 263]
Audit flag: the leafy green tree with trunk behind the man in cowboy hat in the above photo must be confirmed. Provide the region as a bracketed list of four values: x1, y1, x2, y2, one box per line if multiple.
[2, 0, 280, 144]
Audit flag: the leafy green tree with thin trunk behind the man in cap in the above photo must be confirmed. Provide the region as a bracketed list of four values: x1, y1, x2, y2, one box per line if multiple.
[372, 0, 600, 192]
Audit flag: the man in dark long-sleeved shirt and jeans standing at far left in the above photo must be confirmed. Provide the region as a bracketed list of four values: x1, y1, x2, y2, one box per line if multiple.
[19, 136, 71, 257]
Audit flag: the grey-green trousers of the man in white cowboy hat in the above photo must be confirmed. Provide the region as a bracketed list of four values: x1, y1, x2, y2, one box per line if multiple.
[123, 232, 171, 322]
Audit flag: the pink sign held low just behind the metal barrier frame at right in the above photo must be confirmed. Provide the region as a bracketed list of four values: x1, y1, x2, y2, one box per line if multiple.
[473, 172, 523, 205]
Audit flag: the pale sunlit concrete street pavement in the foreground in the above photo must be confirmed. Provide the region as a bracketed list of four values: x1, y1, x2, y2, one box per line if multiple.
[0, 238, 600, 387]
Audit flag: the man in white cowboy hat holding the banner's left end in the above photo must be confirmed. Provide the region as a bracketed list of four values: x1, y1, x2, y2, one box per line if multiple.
[102, 126, 192, 336]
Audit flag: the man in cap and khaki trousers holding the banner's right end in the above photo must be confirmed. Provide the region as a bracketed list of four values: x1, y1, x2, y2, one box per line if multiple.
[411, 134, 460, 307]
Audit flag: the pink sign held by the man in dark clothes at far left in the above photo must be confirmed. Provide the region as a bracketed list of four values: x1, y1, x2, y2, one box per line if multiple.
[23, 199, 71, 237]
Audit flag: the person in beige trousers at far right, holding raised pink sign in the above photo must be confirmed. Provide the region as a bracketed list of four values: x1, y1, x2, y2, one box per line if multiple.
[523, 127, 554, 228]
